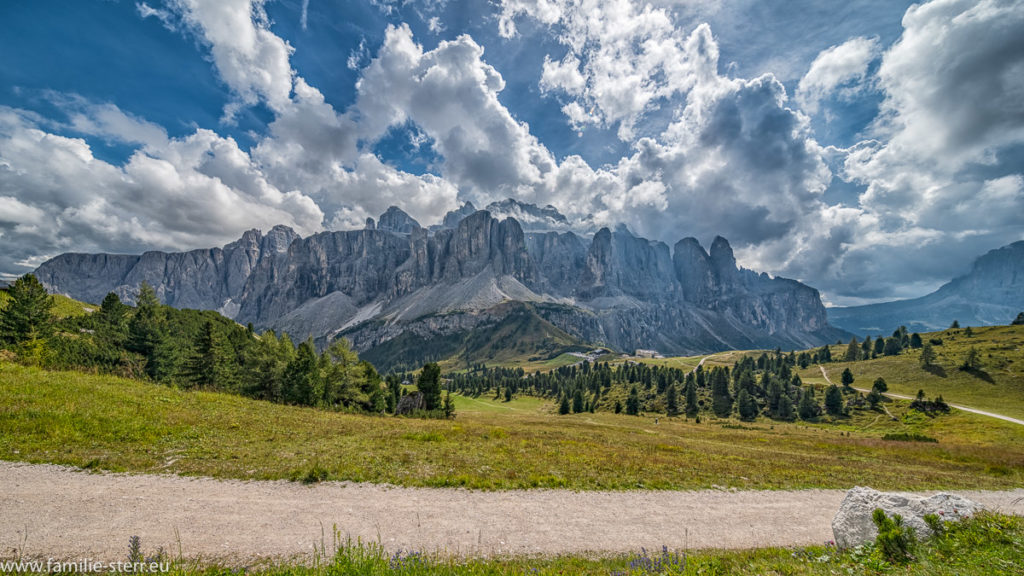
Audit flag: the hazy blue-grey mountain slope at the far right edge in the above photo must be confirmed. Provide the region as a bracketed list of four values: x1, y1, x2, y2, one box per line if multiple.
[828, 241, 1024, 336]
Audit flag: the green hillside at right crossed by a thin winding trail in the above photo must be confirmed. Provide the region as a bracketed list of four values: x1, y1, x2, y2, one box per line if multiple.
[800, 326, 1024, 418]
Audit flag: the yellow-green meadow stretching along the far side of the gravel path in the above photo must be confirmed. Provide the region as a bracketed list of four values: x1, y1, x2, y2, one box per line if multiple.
[0, 364, 1024, 489]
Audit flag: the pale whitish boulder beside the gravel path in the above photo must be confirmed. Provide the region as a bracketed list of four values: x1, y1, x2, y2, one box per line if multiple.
[833, 486, 984, 548]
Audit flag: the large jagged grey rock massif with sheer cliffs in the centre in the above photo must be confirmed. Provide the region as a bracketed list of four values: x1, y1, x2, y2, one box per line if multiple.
[36, 201, 848, 354]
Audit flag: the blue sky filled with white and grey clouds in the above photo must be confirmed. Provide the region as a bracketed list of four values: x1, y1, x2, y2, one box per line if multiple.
[0, 0, 1024, 305]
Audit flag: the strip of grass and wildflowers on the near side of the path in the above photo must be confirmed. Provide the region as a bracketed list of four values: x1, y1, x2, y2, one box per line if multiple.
[6, 513, 1024, 576]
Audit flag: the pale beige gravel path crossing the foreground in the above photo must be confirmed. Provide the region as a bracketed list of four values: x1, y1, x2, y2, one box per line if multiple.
[0, 462, 1024, 562]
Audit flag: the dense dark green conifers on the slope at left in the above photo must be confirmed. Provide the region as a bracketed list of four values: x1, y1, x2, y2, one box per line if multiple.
[0, 275, 454, 416]
